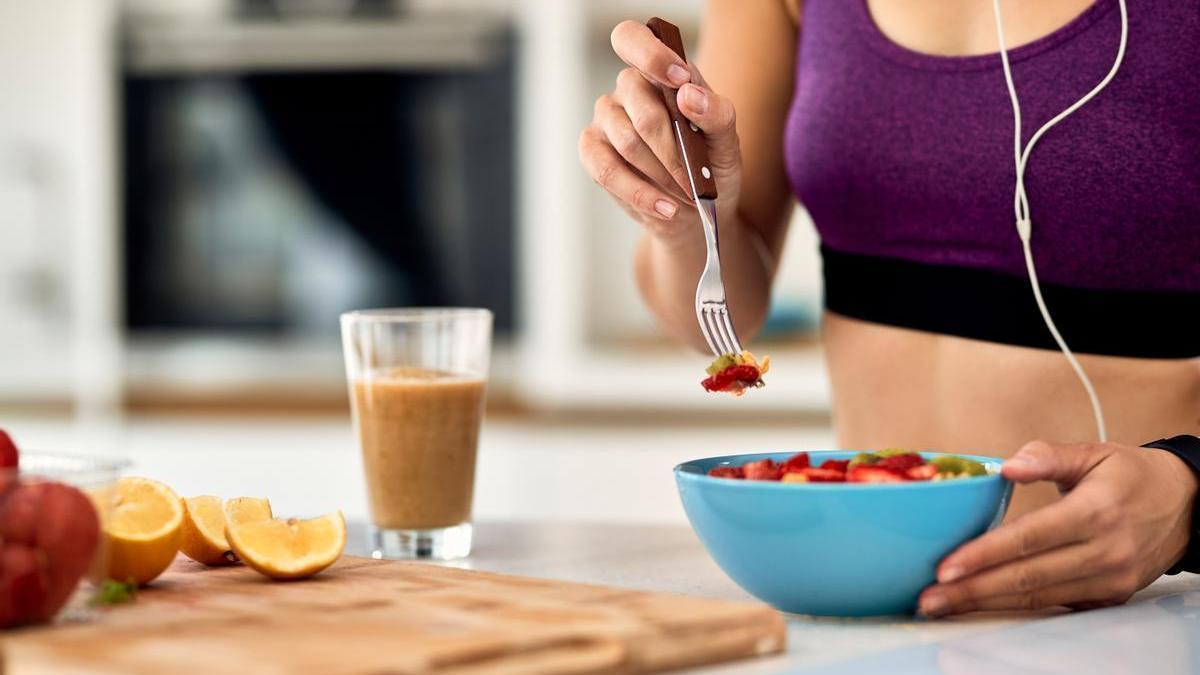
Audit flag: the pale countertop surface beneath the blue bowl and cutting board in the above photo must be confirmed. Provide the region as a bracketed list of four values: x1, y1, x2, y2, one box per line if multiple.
[391, 521, 1200, 675]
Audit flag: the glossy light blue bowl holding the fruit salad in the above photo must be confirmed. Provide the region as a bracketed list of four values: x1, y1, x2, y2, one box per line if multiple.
[674, 452, 1013, 616]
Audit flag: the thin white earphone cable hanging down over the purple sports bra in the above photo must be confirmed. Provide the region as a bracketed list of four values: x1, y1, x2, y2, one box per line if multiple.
[991, 0, 1129, 443]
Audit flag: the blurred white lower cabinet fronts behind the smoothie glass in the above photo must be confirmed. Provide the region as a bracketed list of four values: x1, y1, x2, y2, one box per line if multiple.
[9, 411, 833, 525]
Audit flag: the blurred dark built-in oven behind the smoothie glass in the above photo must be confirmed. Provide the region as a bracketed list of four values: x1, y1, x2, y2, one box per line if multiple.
[119, 4, 516, 345]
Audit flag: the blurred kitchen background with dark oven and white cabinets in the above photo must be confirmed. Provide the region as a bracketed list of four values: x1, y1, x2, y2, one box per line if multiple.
[0, 0, 832, 521]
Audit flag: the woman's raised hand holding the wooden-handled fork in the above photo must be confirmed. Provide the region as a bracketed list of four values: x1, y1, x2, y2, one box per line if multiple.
[580, 20, 742, 239]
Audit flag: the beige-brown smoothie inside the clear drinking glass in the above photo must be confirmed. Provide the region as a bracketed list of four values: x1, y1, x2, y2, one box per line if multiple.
[353, 369, 485, 530]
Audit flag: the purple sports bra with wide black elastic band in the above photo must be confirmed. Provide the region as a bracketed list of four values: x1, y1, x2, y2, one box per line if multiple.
[785, 0, 1200, 358]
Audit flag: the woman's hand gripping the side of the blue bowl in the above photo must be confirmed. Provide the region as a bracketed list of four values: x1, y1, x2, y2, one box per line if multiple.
[919, 441, 1196, 616]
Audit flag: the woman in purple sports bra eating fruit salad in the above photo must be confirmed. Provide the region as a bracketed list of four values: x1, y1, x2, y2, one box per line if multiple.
[580, 0, 1200, 616]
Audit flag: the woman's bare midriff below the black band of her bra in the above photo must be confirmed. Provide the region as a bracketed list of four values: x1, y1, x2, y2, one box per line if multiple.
[822, 312, 1200, 516]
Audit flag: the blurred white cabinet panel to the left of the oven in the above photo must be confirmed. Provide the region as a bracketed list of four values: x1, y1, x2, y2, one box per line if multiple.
[0, 0, 120, 410]
